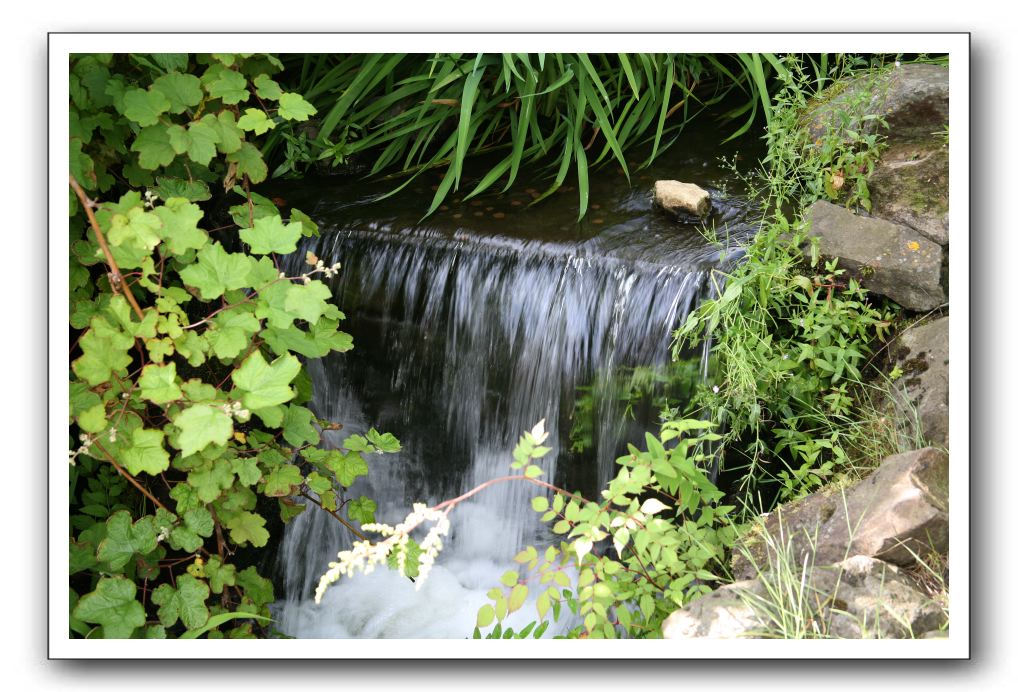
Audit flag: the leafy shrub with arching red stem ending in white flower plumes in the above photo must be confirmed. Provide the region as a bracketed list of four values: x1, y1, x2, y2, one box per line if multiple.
[316, 420, 735, 638]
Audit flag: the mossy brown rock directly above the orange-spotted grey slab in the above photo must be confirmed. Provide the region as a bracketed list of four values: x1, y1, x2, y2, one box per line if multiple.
[867, 145, 949, 245]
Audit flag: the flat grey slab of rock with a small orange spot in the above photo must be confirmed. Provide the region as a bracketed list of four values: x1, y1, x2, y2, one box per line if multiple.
[807, 201, 945, 310]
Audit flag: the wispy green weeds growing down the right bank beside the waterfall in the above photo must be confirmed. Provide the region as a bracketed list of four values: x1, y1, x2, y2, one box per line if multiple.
[675, 58, 895, 510]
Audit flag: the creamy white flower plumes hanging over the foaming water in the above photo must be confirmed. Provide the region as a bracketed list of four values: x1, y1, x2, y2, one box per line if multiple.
[315, 503, 449, 603]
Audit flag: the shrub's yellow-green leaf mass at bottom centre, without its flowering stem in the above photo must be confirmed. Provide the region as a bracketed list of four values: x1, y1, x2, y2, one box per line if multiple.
[474, 419, 735, 639]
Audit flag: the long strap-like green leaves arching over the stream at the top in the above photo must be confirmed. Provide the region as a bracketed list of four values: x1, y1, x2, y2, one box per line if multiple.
[268, 53, 778, 218]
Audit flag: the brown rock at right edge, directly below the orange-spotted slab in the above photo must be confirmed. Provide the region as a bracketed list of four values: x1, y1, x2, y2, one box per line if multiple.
[891, 318, 950, 448]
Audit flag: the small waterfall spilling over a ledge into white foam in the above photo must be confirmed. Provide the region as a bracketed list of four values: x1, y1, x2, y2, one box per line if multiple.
[266, 144, 752, 638]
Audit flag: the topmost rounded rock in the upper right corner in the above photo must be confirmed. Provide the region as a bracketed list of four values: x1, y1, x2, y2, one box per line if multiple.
[807, 65, 949, 143]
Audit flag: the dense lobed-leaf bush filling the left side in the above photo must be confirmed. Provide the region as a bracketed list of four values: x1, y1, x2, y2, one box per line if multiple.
[68, 54, 399, 638]
